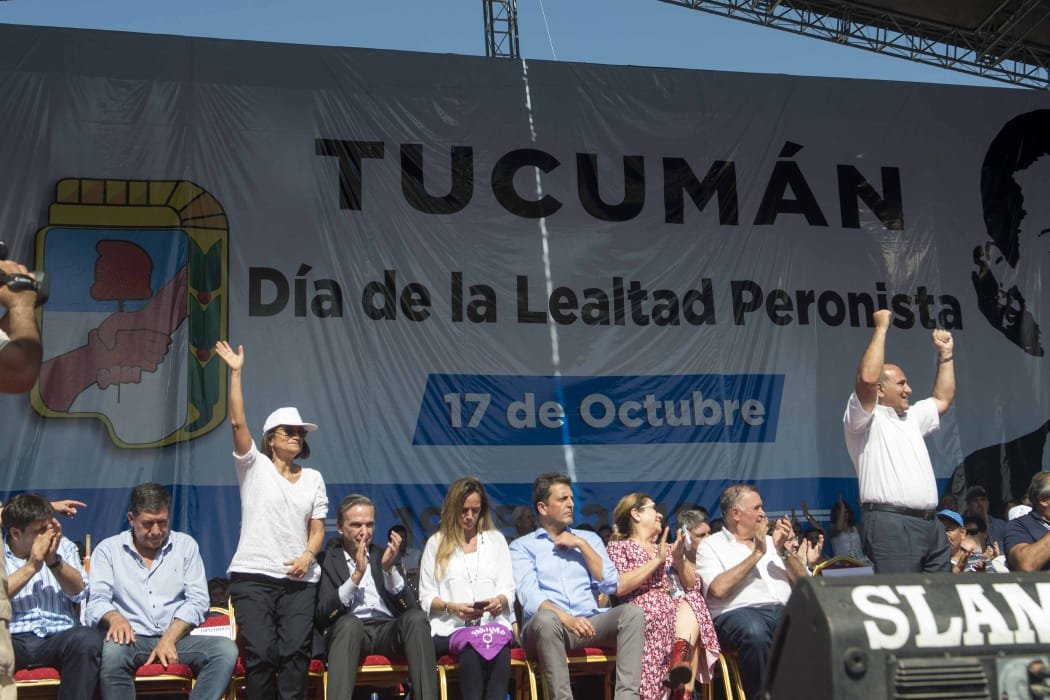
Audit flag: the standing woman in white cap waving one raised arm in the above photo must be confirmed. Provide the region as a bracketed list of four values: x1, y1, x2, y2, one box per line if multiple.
[215, 340, 328, 700]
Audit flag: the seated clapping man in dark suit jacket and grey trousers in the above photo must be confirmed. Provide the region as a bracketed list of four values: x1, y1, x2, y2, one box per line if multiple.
[317, 494, 438, 700]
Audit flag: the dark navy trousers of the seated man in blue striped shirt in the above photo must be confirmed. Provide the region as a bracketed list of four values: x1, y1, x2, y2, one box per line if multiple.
[11, 627, 102, 700]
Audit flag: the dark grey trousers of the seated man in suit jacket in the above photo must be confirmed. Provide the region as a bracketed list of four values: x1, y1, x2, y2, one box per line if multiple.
[319, 608, 438, 700]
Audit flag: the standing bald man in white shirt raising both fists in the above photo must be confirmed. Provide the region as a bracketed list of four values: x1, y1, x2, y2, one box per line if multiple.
[842, 309, 956, 573]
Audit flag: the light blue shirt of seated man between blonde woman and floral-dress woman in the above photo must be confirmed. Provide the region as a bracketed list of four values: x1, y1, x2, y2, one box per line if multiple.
[510, 528, 620, 624]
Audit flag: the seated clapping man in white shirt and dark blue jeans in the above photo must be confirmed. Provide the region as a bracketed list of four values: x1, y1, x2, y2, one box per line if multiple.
[696, 484, 809, 700]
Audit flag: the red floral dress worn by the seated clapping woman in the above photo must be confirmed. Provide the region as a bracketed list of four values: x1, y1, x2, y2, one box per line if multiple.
[606, 539, 680, 700]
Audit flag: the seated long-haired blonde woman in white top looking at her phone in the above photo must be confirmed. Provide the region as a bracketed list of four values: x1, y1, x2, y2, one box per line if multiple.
[419, 476, 515, 700]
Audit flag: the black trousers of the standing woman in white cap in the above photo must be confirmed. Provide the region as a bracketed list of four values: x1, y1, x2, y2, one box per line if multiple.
[230, 572, 317, 700]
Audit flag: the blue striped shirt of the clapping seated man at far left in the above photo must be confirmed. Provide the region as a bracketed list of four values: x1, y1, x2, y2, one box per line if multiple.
[3, 537, 88, 637]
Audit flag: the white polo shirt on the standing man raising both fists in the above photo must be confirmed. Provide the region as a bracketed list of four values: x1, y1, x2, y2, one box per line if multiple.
[842, 393, 941, 510]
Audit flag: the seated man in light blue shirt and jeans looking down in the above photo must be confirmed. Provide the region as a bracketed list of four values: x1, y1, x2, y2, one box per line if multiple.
[85, 483, 237, 700]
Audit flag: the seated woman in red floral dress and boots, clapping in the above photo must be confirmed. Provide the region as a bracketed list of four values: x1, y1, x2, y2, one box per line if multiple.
[608, 493, 718, 700]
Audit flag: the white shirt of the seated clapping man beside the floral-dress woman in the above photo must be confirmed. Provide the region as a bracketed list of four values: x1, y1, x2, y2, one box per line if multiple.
[696, 528, 791, 618]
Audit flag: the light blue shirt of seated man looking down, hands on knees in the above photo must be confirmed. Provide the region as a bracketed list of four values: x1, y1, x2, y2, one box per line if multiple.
[85, 530, 209, 637]
